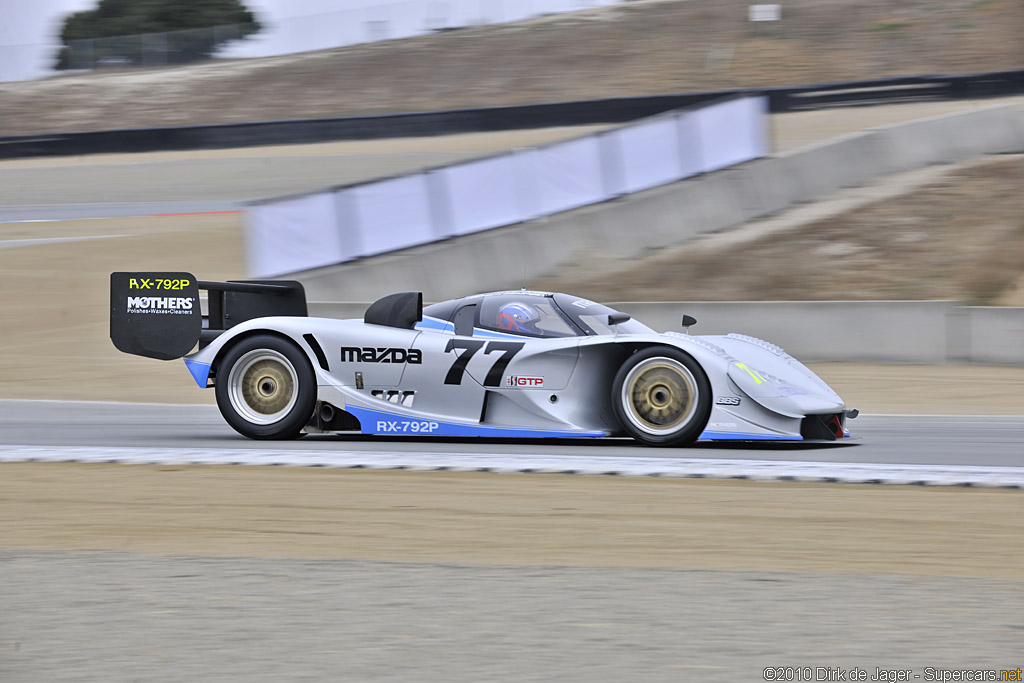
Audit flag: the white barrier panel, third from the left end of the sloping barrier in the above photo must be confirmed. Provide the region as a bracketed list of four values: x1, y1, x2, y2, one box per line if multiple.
[436, 155, 534, 234]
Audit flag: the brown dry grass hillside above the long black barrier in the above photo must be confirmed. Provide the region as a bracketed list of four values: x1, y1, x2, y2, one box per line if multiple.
[0, 0, 1024, 135]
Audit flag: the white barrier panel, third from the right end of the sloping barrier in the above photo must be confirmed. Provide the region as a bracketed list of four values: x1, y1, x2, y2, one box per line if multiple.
[515, 136, 610, 216]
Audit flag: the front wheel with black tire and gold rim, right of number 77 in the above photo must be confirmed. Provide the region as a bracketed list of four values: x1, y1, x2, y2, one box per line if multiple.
[611, 346, 712, 445]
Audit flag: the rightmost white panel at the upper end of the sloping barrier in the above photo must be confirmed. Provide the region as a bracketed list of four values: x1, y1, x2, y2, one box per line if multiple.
[690, 97, 768, 172]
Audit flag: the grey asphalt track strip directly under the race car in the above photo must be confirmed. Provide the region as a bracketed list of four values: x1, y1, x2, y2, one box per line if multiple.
[0, 400, 1024, 467]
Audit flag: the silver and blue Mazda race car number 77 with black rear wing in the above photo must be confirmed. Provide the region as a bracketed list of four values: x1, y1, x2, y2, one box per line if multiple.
[111, 272, 857, 446]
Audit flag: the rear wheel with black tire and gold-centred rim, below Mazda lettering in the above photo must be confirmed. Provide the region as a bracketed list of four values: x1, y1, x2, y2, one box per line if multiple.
[216, 335, 316, 439]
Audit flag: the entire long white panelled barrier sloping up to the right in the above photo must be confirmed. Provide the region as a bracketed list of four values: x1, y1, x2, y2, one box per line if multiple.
[243, 96, 767, 276]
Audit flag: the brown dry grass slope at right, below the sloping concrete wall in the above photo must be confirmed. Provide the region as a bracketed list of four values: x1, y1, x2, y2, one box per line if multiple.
[531, 157, 1024, 305]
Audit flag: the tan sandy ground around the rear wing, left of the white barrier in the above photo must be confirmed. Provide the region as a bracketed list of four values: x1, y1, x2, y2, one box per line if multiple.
[0, 214, 243, 401]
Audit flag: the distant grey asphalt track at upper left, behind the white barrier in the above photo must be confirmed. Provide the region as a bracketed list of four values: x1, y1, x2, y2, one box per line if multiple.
[0, 126, 605, 222]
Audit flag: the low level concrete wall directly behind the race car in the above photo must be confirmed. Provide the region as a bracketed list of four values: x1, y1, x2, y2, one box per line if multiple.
[309, 301, 1024, 366]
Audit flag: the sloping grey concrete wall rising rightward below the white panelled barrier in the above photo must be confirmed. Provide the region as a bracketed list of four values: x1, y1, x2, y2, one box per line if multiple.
[296, 104, 1024, 300]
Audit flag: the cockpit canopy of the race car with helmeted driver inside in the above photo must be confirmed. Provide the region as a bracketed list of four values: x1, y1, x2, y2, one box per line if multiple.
[423, 290, 653, 338]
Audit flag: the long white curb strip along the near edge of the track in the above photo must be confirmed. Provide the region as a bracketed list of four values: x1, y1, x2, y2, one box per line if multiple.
[0, 445, 1024, 488]
